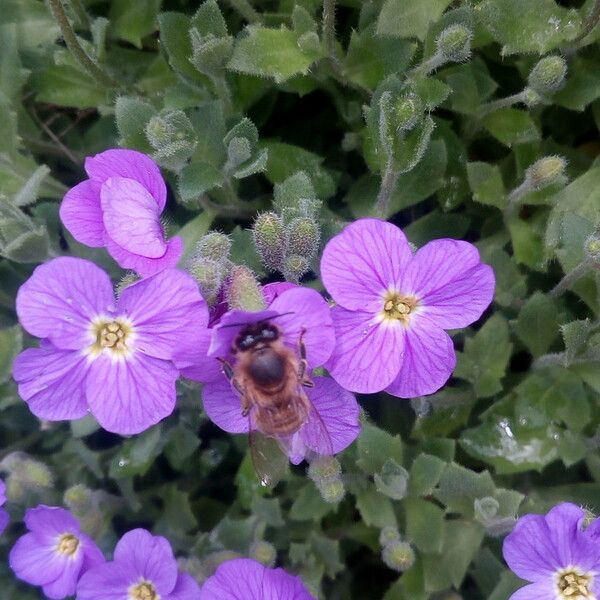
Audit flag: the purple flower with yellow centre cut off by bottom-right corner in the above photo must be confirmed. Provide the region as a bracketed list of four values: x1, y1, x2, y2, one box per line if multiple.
[503, 502, 600, 600]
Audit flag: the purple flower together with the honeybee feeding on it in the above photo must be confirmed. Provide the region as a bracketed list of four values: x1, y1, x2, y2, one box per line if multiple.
[175, 286, 360, 464]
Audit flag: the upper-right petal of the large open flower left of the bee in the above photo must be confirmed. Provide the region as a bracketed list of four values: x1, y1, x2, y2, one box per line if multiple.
[117, 269, 208, 360]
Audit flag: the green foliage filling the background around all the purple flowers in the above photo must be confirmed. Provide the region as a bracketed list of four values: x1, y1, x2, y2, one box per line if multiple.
[0, 0, 600, 600]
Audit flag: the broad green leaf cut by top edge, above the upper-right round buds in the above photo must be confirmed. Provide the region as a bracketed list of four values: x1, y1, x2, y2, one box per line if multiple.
[476, 0, 581, 54]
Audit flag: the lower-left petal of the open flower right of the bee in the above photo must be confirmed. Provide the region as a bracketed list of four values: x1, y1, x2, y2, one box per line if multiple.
[325, 306, 404, 394]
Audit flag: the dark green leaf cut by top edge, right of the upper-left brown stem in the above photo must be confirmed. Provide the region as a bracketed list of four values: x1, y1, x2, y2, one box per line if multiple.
[109, 0, 162, 48]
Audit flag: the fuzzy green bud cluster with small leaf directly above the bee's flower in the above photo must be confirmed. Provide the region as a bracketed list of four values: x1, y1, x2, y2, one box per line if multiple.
[252, 173, 321, 283]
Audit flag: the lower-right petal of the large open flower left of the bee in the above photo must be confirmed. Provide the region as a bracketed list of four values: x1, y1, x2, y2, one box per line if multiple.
[86, 353, 178, 435]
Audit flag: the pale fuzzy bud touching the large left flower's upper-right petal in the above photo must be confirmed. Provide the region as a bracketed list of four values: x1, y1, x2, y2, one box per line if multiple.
[187, 231, 231, 305]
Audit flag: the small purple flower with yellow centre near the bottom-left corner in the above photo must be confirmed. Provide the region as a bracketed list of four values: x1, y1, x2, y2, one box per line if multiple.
[9, 505, 104, 598]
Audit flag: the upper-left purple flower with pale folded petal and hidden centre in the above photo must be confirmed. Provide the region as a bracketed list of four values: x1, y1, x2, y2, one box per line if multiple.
[60, 149, 183, 277]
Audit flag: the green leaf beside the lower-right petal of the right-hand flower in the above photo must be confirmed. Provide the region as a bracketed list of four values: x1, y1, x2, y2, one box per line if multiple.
[454, 314, 512, 398]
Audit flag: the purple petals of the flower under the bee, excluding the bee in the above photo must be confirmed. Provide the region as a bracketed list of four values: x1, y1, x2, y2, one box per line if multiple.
[175, 286, 360, 464]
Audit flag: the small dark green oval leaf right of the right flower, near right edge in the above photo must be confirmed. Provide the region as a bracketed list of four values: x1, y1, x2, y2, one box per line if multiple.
[515, 292, 559, 357]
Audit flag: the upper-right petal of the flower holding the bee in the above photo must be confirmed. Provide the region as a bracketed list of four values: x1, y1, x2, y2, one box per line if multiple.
[269, 287, 335, 369]
